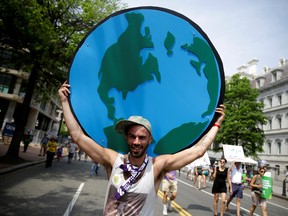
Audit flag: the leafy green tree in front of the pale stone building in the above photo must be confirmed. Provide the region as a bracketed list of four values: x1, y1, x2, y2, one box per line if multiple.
[215, 74, 267, 157]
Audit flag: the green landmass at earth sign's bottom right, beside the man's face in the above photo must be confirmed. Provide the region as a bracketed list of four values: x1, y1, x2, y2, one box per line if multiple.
[154, 121, 209, 154]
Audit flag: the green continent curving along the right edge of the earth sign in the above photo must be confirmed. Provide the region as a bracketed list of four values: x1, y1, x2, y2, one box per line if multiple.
[181, 37, 219, 117]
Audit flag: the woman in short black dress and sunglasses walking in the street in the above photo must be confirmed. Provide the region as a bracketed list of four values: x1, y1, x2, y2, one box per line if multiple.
[212, 158, 232, 216]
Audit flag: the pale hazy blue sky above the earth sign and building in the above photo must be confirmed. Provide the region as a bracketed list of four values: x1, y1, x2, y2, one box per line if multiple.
[122, 0, 288, 76]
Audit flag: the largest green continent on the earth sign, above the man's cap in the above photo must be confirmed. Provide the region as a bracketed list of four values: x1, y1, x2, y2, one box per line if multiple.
[97, 13, 161, 123]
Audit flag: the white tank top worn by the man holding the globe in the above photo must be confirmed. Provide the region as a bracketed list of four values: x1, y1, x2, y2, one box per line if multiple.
[103, 154, 157, 216]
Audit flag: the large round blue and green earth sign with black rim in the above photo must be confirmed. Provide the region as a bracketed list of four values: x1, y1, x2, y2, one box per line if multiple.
[69, 7, 225, 156]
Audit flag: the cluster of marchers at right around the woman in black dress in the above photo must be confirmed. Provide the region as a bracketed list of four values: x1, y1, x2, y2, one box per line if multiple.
[187, 158, 267, 216]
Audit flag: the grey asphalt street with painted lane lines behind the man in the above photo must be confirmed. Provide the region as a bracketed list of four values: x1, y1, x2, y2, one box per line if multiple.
[0, 158, 288, 216]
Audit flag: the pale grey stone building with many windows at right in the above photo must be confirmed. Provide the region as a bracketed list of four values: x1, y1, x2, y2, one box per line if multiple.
[234, 58, 288, 180]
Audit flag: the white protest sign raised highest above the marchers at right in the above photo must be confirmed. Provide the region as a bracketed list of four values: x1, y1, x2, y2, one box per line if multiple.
[223, 145, 245, 162]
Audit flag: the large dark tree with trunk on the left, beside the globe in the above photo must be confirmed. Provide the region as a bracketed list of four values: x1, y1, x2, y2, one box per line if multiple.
[0, 0, 126, 162]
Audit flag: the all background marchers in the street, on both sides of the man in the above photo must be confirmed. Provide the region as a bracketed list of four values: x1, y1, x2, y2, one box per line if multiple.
[21, 129, 267, 216]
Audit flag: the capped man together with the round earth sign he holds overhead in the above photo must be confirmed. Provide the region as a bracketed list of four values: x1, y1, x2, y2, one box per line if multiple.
[58, 7, 225, 215]
